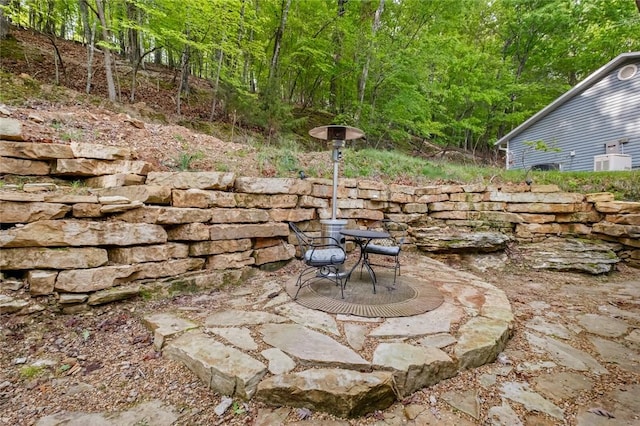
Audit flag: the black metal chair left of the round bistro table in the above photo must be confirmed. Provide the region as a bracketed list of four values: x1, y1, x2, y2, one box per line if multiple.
[289, 222, 347, 300]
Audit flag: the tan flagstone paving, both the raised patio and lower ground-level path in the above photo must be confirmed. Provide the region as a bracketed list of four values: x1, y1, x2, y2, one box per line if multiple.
[32, 258, 640, 426]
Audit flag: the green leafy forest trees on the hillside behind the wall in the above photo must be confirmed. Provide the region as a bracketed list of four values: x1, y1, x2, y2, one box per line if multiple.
[0, 0, 640, 160]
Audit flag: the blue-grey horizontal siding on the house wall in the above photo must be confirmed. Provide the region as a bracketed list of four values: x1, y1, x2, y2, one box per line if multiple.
[507, 58, 640, 170]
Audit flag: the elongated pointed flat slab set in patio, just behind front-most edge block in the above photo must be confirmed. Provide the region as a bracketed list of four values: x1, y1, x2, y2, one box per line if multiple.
[260, 324, 369, 370]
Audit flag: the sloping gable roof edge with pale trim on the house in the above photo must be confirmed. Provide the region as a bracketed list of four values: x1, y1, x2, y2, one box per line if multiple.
[494, 52, 640, 145]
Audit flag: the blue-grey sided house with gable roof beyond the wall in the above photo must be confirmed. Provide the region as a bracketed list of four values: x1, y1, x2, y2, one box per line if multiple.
[495, 52, 640, 171]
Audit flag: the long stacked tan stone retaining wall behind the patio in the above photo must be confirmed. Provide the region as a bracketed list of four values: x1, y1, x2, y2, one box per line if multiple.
[0, 140, 640, 308]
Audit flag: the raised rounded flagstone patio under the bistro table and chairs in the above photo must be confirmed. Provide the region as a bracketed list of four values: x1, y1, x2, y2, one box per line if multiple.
[145, 257, 514, 418]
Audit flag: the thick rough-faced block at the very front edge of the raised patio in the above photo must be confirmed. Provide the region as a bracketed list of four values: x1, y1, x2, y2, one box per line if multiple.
[256, 369, 396, 418]
